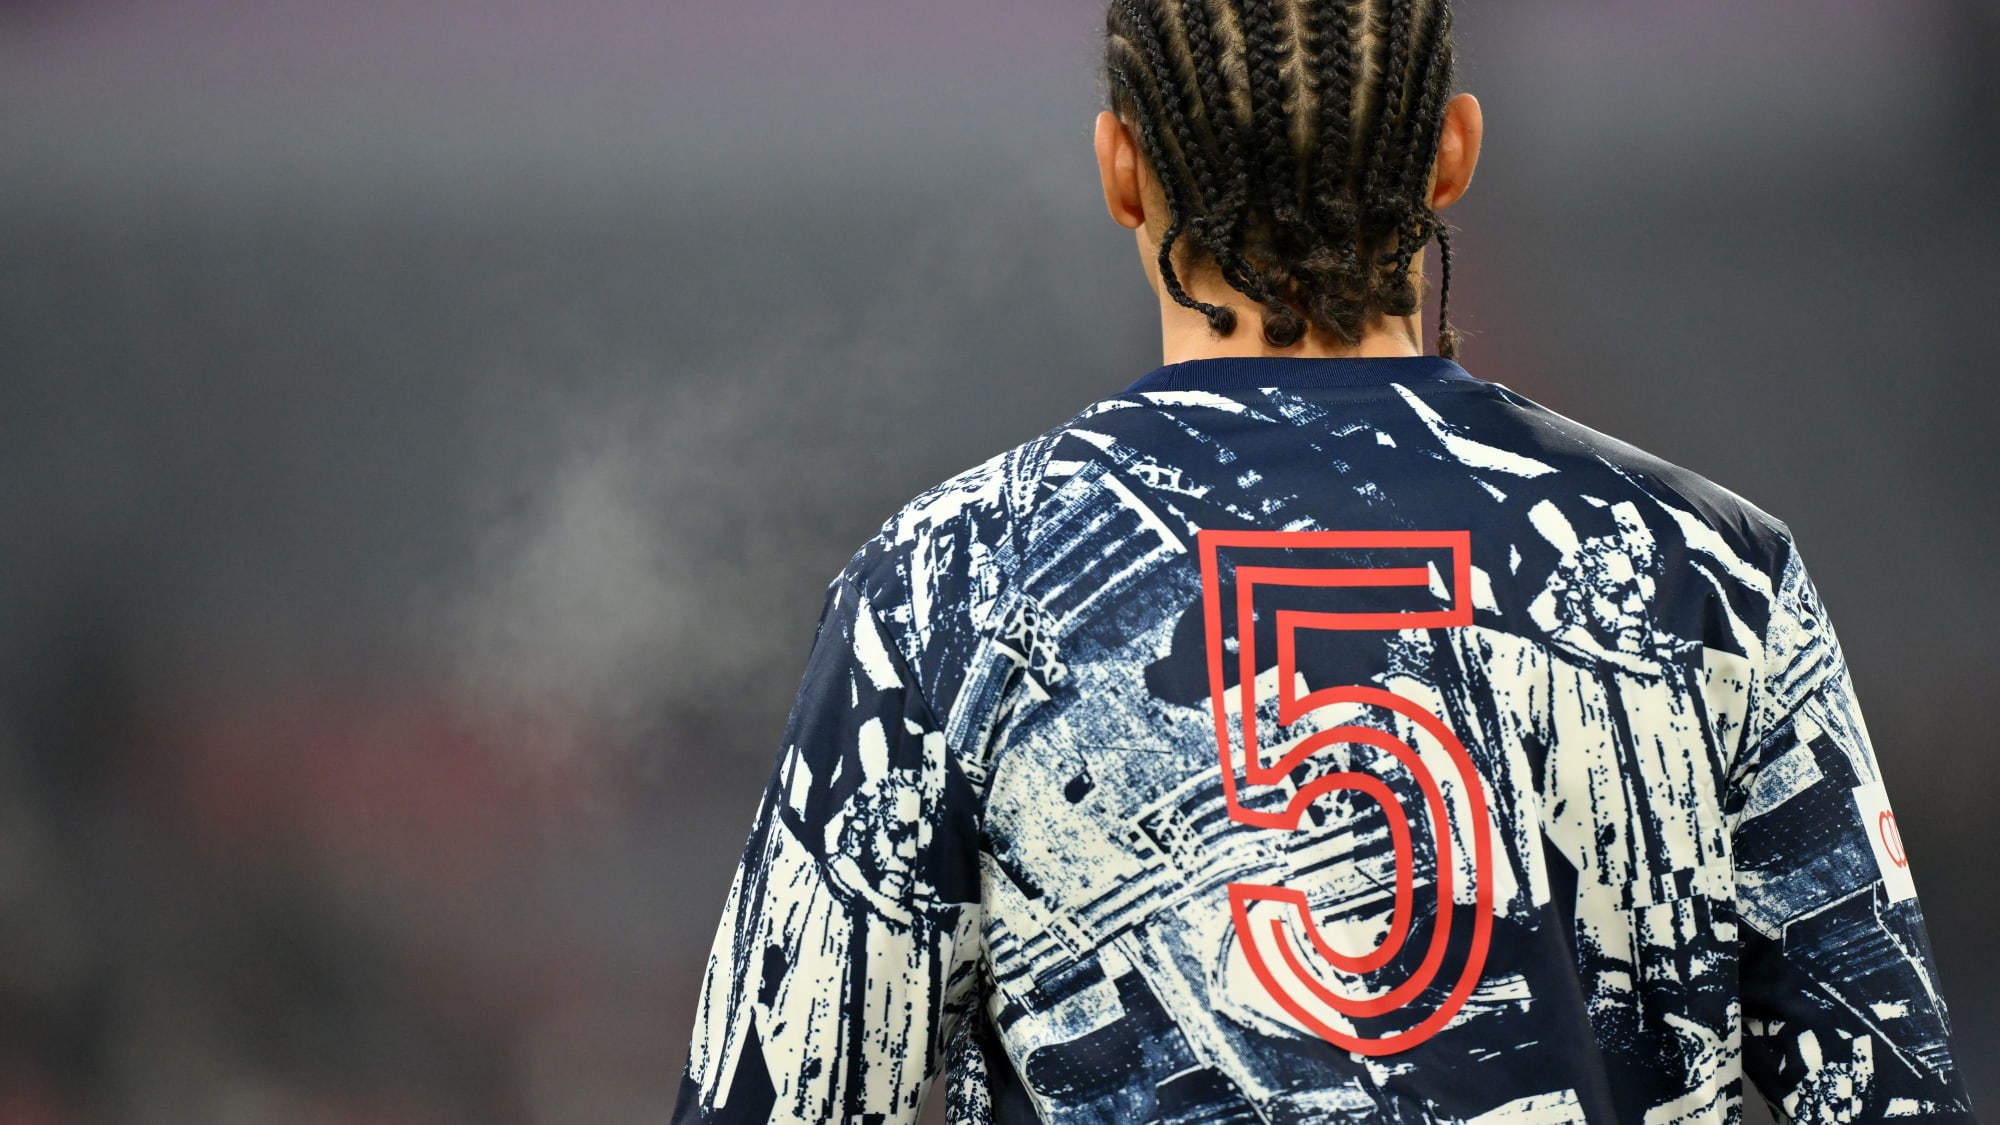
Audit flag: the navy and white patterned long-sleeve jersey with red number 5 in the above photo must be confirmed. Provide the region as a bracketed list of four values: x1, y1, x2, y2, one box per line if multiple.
[676, 358, 1972, 1125]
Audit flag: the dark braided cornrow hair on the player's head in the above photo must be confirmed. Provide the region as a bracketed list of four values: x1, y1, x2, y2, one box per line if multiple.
[1104, 0, 1458, 358]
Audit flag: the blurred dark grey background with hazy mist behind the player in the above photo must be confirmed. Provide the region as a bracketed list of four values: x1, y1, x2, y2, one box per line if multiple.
[0, 0, 2000, 1125]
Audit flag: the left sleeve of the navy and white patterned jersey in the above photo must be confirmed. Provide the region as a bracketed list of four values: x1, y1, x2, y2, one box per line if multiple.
[674, 577, 980, 1123]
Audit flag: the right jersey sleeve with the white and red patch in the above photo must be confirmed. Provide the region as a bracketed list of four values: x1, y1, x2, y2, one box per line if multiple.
[1730, 548, 1972, 1123]
